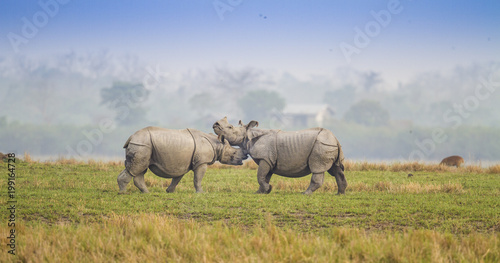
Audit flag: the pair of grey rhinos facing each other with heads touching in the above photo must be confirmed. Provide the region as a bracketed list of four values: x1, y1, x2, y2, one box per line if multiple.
[117, 118, 347, 197]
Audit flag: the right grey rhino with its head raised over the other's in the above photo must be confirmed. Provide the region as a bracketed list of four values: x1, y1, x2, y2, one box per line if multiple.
[213, 117, 347, 194]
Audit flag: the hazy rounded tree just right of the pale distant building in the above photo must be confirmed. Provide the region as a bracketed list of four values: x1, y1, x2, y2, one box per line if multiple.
[344, 100, 389, 126]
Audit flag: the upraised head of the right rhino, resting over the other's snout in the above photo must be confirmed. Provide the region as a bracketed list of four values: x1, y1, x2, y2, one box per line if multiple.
[212, 117, 259, 147]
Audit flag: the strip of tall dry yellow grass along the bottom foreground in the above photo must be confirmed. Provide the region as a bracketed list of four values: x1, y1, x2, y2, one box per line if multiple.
[0, 214, 500, 262]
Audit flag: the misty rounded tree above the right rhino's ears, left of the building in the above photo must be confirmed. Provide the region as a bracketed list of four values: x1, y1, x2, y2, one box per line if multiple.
[238, 90, 285, 120]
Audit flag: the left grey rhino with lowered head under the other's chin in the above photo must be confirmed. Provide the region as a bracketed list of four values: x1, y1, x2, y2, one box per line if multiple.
[117, 127, 247, 193]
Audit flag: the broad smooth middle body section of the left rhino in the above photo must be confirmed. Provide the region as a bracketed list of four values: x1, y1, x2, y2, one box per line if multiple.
[148, 127, 195, 177]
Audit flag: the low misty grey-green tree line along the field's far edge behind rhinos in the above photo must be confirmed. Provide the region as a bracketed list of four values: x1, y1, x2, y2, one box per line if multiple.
[0, 117, 500, 161]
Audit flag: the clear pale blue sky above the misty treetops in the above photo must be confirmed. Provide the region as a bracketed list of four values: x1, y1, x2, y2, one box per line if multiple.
[0, 0, 500, 82]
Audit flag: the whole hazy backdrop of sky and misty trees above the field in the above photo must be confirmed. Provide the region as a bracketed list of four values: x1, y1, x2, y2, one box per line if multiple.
[0, 0, 500, 161]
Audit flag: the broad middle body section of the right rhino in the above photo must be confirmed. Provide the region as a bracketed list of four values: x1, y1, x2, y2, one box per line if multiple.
[275, 128, 321, 177]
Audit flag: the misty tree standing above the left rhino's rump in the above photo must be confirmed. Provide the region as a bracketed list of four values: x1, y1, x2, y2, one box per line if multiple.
[101, 82, 149, 126]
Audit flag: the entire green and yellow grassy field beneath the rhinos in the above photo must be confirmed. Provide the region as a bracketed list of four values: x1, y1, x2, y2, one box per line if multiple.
[0, 158, 500, 262]
